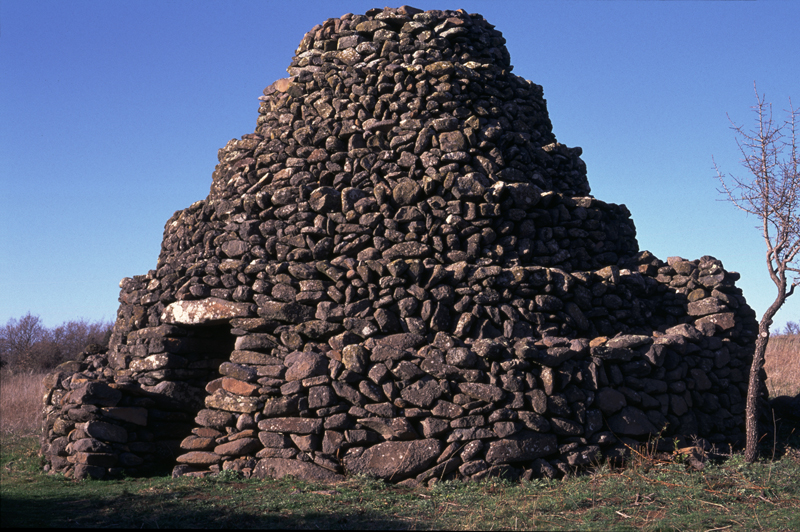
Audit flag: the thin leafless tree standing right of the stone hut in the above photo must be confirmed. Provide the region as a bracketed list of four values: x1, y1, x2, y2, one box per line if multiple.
[714, 83, 800, 462]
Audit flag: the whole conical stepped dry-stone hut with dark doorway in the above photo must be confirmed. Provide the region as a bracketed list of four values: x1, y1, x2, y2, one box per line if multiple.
[42, 7, 757, 485]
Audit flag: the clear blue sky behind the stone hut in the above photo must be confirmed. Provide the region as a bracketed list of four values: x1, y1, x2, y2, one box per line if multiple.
[0, 0, 800, 327]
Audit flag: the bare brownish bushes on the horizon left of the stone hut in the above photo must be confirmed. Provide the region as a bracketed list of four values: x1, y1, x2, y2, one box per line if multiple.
[0, 312, 113, 372]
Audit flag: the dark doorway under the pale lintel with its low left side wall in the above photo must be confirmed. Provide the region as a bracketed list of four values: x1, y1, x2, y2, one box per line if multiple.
[43, 324, 235, 478]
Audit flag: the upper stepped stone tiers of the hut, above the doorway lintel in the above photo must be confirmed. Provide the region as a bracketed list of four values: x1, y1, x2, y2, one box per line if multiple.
[159, 8, 638, 286]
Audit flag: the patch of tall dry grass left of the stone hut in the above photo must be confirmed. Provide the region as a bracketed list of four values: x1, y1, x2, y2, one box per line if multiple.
[0, 371, 44, 436]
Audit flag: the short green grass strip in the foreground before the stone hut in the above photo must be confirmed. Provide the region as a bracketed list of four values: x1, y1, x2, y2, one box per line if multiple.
[0, 430, 800, 531]
